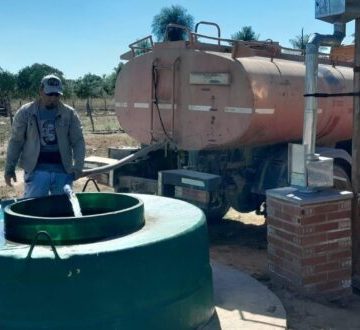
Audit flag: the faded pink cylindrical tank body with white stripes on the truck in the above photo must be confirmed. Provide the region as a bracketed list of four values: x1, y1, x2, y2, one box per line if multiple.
[115, 36, 353, 150]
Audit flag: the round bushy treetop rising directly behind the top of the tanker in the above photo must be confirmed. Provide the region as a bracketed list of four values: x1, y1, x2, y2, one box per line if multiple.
[151, 5, 194, 41]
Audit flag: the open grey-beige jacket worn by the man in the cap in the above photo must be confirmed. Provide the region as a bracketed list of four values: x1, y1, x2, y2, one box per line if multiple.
[5, 101, 85, 176]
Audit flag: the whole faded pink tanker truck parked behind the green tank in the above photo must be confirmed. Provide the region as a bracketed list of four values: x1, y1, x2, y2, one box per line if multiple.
[105, 22, 353, 219]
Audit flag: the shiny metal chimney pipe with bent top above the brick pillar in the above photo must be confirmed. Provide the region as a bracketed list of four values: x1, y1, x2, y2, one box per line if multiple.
[303, 23, 346, 160]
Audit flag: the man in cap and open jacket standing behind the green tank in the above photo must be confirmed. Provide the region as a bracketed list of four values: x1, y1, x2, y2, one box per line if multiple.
[5, 74, 85, 198]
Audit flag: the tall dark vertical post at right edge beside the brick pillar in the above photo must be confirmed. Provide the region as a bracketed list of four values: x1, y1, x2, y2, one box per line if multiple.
[351, 18, 360, 289]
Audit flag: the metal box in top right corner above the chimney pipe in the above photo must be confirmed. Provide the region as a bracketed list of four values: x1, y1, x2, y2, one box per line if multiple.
[315, 0, 360, 23]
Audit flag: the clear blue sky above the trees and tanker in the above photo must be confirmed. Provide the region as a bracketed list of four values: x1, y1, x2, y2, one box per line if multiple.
[0, 0, 355, 79]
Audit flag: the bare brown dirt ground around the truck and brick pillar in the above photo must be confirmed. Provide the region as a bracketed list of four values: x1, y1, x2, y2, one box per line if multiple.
[0, 133, 360, 330]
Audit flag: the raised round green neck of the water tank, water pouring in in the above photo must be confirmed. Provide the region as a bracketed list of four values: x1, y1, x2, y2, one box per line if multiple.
[4, 193, 145, 245]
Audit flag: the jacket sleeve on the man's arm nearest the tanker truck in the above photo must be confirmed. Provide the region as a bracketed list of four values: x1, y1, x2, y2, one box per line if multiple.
[70, 110, 85, 173]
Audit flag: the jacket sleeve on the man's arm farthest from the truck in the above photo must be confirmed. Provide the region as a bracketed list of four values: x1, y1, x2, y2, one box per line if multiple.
[5, 108, 28, 175]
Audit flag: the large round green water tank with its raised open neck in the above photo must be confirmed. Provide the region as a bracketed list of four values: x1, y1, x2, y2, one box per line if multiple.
[0, 193, 214, 330]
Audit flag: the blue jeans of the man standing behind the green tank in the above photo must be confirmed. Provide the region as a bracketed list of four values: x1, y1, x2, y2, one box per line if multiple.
[24, 170, 74, 198]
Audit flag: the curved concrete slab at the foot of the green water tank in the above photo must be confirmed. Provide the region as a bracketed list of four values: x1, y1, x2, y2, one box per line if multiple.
[203, 261, 287, 330]
